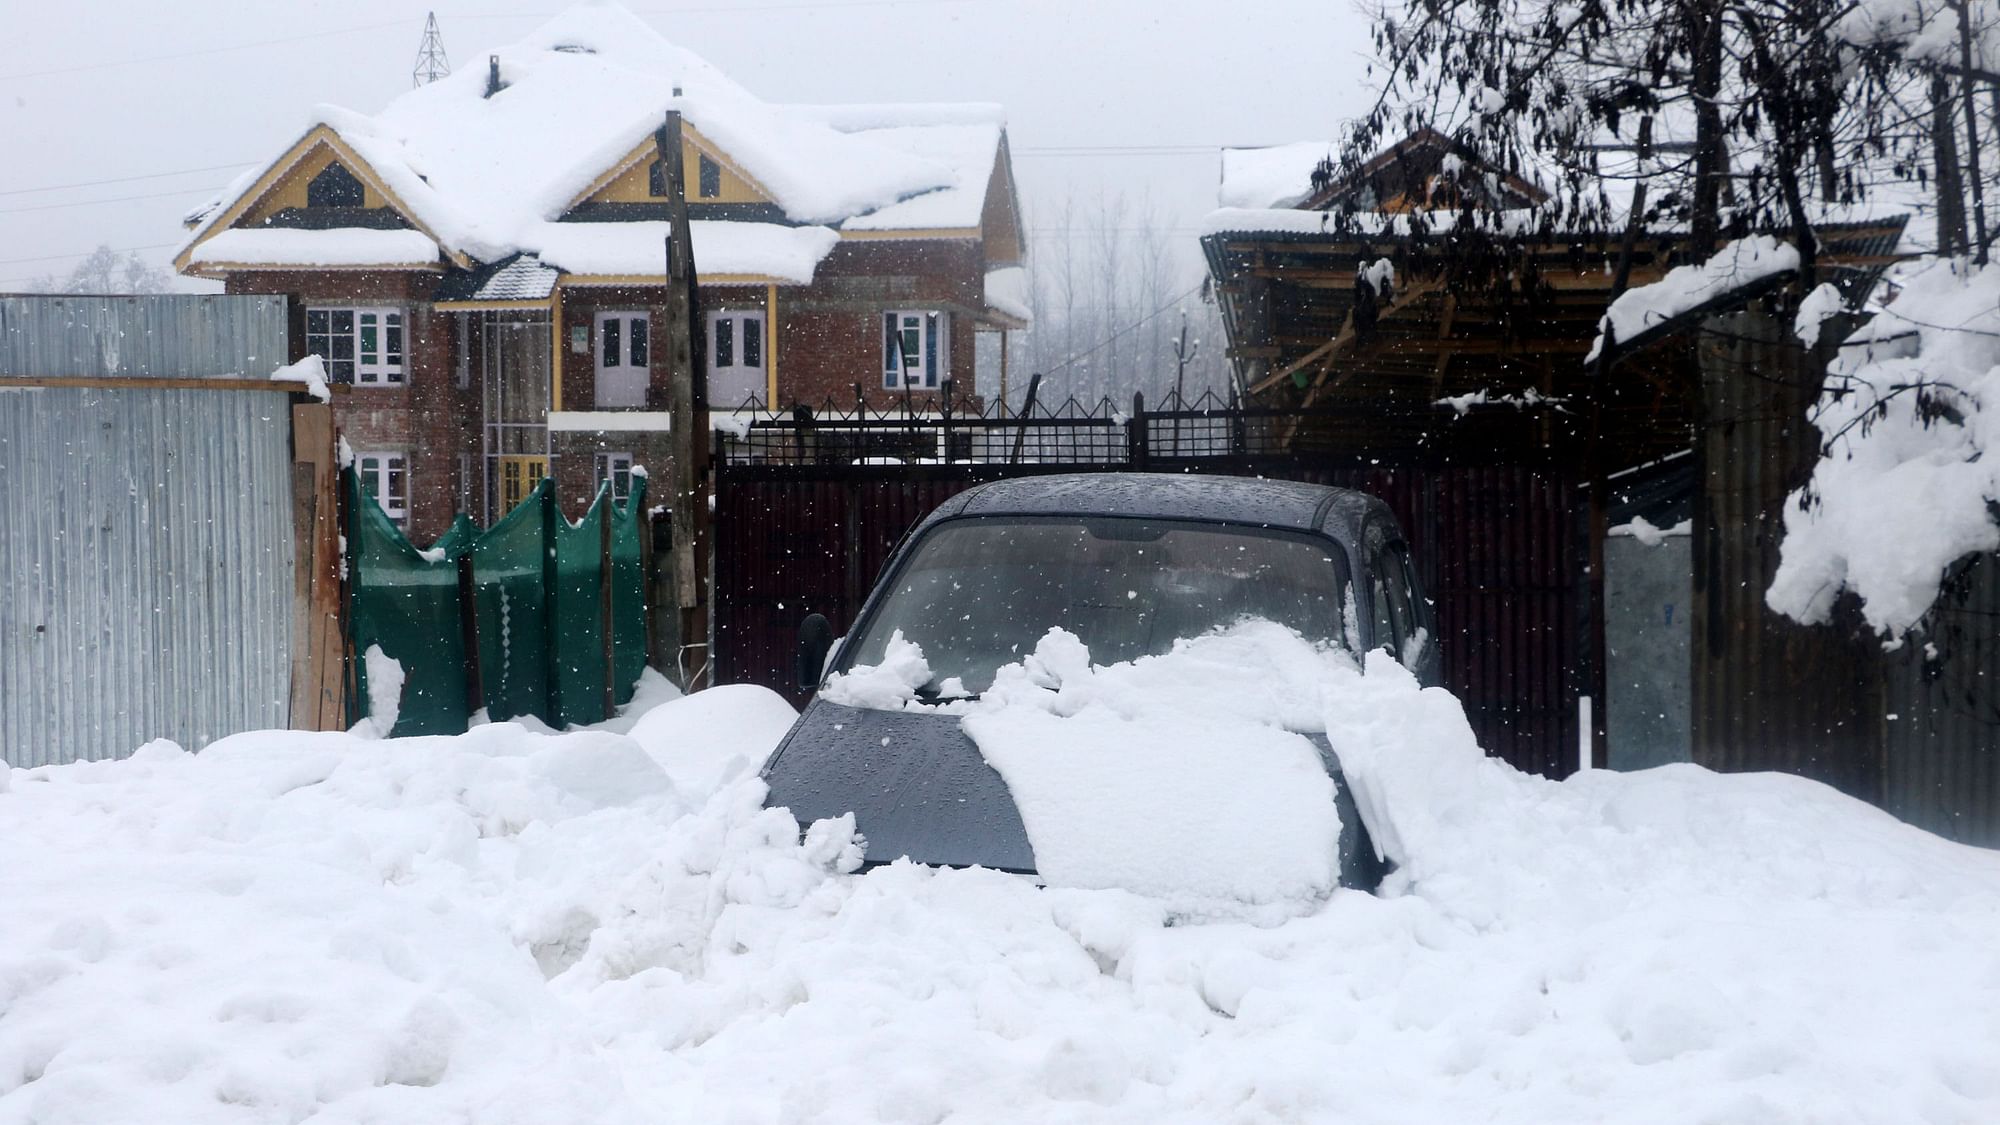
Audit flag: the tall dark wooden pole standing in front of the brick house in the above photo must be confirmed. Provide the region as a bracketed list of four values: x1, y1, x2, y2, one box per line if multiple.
[654, 107, 712, 691]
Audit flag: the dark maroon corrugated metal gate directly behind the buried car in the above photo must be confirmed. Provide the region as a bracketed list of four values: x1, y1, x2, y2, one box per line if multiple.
[714, 458, 1586, 777]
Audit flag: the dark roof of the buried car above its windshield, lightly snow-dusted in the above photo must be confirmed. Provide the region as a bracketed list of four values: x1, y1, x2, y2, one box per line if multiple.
[926, 472, 1380, 530]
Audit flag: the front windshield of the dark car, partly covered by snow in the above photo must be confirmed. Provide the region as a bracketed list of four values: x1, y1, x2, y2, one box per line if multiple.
[840, 518, 1348, 695]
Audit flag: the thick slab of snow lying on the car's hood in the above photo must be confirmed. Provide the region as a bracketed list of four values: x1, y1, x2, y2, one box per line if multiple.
[964, 623, 1348, 915]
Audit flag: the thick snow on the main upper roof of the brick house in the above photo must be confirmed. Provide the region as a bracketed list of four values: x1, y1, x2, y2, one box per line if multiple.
[190, 0, 1002, 272]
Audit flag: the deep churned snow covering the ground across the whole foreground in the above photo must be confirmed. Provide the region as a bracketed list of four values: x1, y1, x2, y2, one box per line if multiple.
[0, 639, 2000, 1125]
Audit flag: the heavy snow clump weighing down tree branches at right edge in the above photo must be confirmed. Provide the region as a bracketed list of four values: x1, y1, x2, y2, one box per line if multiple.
[1766, 258, 2000, 639]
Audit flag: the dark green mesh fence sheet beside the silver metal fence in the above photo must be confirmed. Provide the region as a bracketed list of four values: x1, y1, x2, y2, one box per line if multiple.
[342, 470, 646, 737]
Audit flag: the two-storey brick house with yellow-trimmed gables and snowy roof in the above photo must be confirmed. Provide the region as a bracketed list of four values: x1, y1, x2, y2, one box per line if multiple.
[176, 2, 1028, 542]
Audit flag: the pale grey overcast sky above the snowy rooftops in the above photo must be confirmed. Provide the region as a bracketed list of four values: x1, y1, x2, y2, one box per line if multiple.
[0, 0, 1368, 290]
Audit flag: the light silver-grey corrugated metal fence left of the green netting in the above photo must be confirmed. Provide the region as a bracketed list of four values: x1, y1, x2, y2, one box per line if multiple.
[0, 296, 294, 767]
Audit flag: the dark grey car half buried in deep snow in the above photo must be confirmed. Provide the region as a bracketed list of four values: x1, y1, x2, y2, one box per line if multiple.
[762, 472, 1438, 887]
